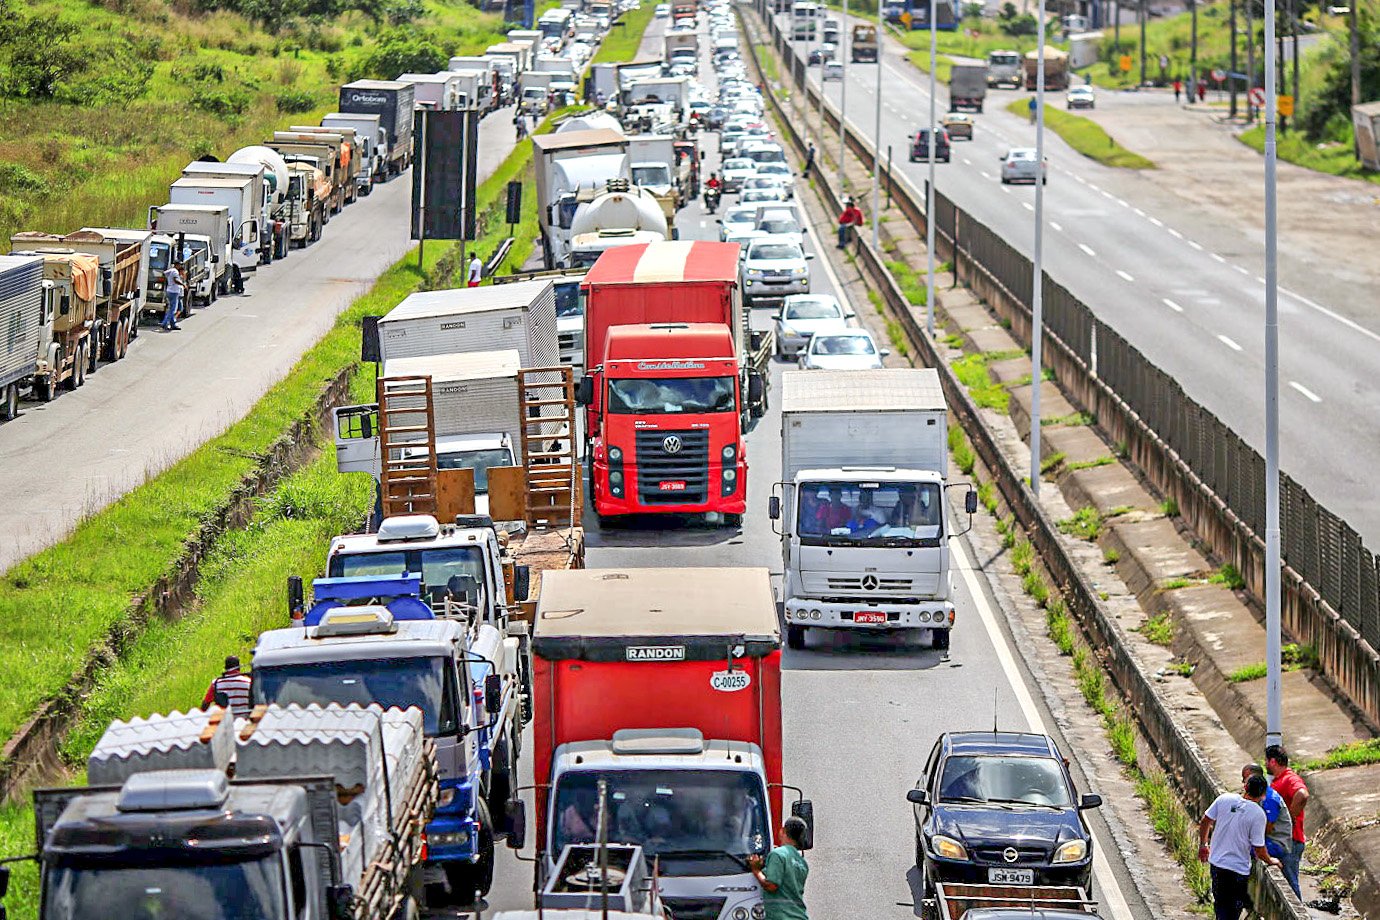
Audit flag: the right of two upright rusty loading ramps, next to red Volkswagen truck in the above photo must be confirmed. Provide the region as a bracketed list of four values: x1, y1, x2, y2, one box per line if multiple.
[518, 364, 585, 530]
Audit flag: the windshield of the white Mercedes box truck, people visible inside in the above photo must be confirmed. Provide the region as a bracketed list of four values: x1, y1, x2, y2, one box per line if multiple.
[796, 481, 943, 546]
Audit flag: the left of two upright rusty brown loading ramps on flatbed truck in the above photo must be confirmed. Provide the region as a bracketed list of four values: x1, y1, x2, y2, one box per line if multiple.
[378, 377, 437, 517]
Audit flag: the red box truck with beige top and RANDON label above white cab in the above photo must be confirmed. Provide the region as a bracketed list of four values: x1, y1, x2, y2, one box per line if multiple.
[509, 568, 813, 920]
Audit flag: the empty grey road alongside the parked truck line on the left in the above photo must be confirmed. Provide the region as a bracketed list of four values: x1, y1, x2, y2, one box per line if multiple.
[0, 109, 513, 571]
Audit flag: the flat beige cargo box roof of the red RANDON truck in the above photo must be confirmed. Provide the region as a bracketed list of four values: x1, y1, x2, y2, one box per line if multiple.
[533, 568, 781, 661]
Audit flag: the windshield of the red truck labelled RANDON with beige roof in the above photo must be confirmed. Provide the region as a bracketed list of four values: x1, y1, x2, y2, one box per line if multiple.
[552, 770, 770, 874]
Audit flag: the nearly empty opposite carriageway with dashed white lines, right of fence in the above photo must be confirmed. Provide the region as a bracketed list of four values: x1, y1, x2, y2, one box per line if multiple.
[778, 16, 1380, 548]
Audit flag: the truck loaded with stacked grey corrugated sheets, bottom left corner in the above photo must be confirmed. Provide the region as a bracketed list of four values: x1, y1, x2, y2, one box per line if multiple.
[0, 705, 439, 920]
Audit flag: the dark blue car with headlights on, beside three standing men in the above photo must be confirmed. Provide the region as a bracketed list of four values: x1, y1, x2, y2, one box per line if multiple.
[905, 731, 1103, 898]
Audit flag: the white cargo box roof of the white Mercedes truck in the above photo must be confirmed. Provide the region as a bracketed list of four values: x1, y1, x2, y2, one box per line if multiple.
[781, 367, 945, 412]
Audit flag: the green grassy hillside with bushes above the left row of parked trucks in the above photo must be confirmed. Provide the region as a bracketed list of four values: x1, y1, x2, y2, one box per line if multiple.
[0, 0, 505, 240]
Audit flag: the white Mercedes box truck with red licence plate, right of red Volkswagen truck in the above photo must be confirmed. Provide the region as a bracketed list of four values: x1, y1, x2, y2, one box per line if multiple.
[769, 368, 977, 648]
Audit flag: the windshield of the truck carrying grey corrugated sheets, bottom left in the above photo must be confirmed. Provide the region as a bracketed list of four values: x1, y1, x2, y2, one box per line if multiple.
[43, 857, 287, 920]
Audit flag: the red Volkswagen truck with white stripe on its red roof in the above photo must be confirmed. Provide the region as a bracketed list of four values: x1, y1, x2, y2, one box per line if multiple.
[580, 240, 771, 526]
